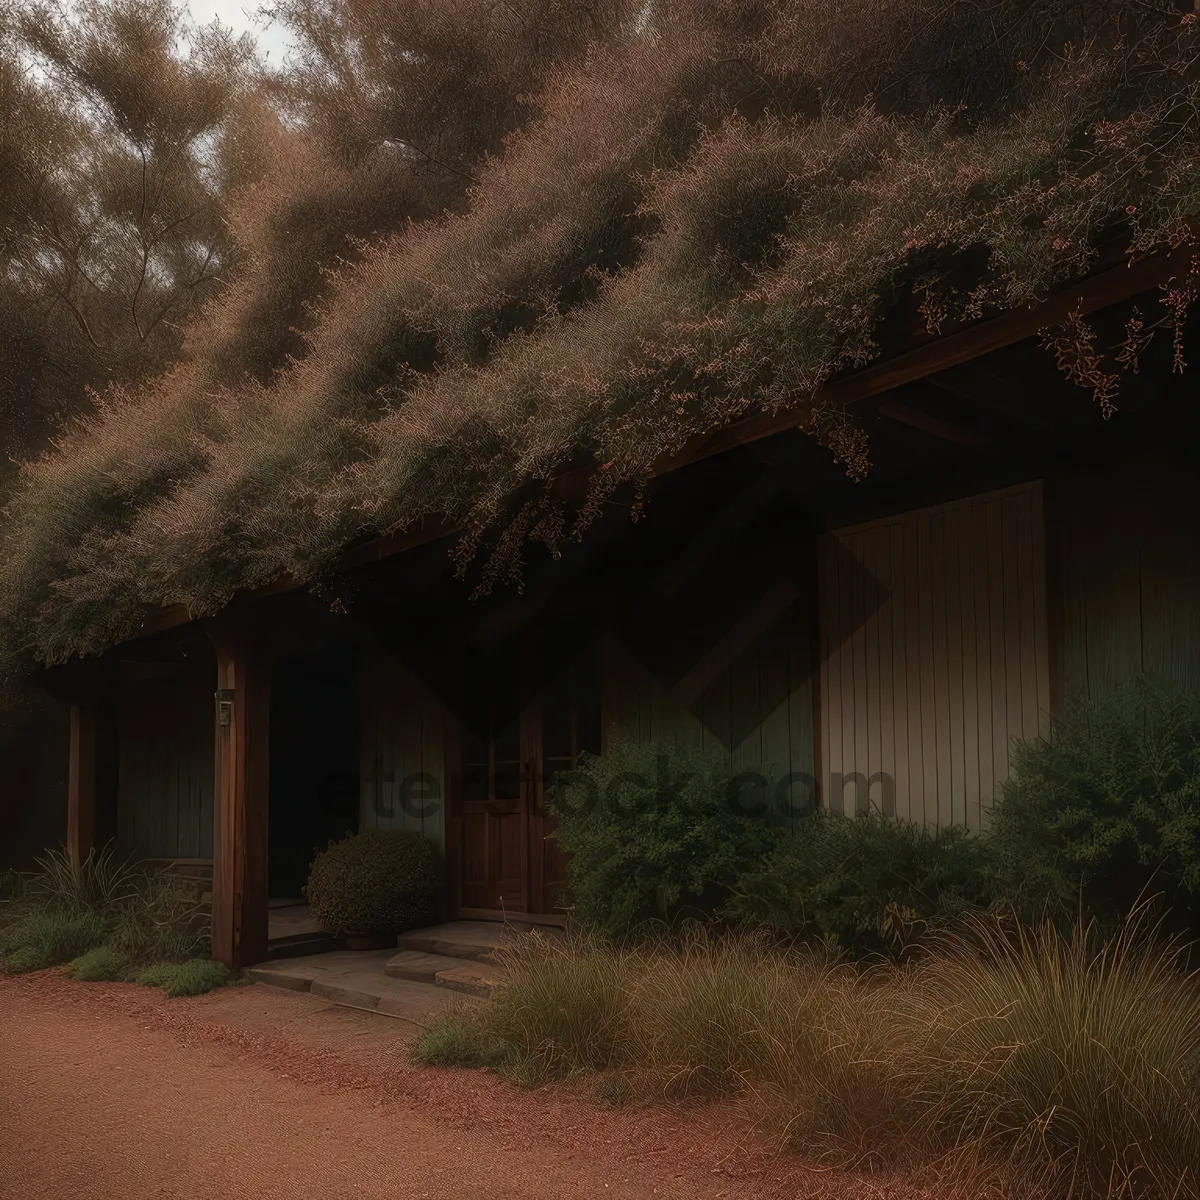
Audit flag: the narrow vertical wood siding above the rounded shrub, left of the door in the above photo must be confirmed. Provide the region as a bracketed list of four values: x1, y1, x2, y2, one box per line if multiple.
[359, 650, 448, 848]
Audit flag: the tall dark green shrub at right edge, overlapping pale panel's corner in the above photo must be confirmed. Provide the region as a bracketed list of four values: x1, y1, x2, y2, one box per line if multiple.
[991, 679, 1200, 932]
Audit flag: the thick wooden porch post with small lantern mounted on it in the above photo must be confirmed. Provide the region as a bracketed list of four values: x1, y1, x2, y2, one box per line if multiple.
[209, 622, 270, 967]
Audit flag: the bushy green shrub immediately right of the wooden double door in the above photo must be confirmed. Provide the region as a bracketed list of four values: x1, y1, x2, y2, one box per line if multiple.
[551, 739, 778, 937]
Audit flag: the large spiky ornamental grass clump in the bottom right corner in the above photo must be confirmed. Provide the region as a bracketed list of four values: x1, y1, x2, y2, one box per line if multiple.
[912, 912, 1200, 1198]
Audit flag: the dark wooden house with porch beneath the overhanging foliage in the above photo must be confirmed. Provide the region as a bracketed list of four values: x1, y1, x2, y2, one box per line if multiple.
[23, 253, 1200, 965]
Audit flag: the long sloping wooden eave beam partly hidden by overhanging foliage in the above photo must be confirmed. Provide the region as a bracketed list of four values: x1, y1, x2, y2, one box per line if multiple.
[121, 238, 1194, 634]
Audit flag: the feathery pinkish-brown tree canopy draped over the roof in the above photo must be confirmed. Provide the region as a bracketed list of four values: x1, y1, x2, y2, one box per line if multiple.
[0, 0, 1200, 661]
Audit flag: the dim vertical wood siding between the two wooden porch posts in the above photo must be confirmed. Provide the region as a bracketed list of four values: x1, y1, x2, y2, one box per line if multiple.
[116, 665, 214, 859]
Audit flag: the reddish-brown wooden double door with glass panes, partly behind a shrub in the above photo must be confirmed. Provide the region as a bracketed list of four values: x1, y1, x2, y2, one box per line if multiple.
[451, 656, 600, 919]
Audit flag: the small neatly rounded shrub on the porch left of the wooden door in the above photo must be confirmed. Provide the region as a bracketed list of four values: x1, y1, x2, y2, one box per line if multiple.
[305, 829, 438, 937]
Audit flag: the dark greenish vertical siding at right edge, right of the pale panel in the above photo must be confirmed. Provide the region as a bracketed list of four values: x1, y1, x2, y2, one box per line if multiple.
[1048, 463, 1200, 701]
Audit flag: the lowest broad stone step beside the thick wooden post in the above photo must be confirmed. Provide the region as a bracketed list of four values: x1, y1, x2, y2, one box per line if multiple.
[250, 950, 479, 1027]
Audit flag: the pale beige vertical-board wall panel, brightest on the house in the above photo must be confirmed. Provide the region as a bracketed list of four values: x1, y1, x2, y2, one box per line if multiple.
[818, 484, 1050, 829]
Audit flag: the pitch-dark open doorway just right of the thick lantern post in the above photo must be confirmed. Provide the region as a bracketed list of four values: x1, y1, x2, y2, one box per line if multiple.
[268, 643, 359, 898]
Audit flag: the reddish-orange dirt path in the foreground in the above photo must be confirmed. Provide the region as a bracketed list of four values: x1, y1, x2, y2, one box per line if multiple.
[0, 972, 936, 1200]
